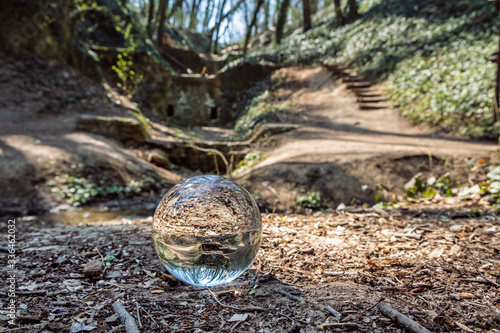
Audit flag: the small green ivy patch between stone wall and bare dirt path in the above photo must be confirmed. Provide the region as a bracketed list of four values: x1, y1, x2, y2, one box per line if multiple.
[234, 90, 292, 140]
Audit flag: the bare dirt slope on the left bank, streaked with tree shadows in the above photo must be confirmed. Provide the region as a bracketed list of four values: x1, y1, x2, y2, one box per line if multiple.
[0, 54, 182, 215]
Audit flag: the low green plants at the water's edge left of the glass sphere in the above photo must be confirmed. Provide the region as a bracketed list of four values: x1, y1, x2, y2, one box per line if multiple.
[46, 174, 164, 206]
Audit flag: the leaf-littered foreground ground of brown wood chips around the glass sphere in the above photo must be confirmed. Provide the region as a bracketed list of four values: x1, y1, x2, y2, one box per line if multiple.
[0, 200, 500, 332]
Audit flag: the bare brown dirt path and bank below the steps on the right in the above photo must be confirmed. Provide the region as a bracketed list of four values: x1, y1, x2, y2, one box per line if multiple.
[238, 67, 498, 211]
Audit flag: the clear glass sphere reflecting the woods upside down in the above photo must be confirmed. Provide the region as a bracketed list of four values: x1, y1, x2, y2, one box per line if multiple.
[153, 175, 262, 287]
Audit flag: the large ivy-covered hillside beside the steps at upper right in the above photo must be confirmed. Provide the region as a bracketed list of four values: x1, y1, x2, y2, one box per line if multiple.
[254, 0, 499, 138]
